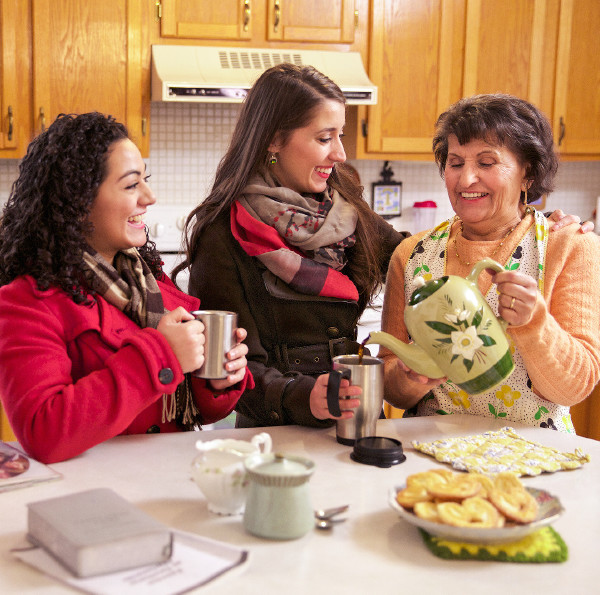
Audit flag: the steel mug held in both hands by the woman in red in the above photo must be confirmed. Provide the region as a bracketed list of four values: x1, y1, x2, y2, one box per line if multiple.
[192, 310, 237, 379]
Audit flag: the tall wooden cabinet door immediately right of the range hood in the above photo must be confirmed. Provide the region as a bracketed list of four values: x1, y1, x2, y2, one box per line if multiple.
[367, 0, 465, 159]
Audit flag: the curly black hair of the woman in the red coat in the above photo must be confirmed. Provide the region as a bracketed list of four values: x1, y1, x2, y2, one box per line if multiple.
[0, 112, 162, 303]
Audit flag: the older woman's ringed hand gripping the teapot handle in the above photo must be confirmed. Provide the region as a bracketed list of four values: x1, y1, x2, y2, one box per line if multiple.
[492, 271, 543, 326]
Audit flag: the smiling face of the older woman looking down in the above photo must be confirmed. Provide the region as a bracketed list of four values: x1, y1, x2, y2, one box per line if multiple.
[444, 134, 527, 240]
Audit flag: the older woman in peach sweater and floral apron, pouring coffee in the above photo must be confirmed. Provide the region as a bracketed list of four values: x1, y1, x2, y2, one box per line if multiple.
[380, 94, 600, 432]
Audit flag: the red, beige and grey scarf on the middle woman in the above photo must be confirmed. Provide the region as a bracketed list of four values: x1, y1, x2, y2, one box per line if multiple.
[231, 173, 358, 301]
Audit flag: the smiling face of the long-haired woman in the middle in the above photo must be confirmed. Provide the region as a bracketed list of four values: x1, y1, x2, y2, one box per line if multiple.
[269, 99, 346, 194]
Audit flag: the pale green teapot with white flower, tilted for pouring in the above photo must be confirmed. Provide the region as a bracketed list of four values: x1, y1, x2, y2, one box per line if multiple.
[366, 258, 514, 395]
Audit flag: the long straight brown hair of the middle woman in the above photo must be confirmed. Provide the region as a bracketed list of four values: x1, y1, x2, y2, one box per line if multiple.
[172, 63, 382, 309]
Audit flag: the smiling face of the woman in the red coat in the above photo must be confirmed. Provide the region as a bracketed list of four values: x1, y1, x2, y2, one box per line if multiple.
[87, 139, 156, 263]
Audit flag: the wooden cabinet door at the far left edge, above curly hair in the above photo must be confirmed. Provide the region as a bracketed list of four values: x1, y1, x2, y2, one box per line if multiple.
[0, 0, 31, 158]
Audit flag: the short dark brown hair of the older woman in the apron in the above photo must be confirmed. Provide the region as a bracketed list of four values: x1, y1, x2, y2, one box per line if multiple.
[433, 93, 558, 202]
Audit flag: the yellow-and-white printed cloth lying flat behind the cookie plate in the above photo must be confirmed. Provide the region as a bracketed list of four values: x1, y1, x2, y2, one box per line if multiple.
[412, 427, 590, 476]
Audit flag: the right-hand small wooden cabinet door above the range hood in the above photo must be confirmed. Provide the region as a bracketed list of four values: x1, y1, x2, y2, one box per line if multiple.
[267, 0, 355, 43]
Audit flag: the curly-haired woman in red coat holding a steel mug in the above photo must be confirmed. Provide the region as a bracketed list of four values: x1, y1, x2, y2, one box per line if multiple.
[0, 113, 253, 463]
